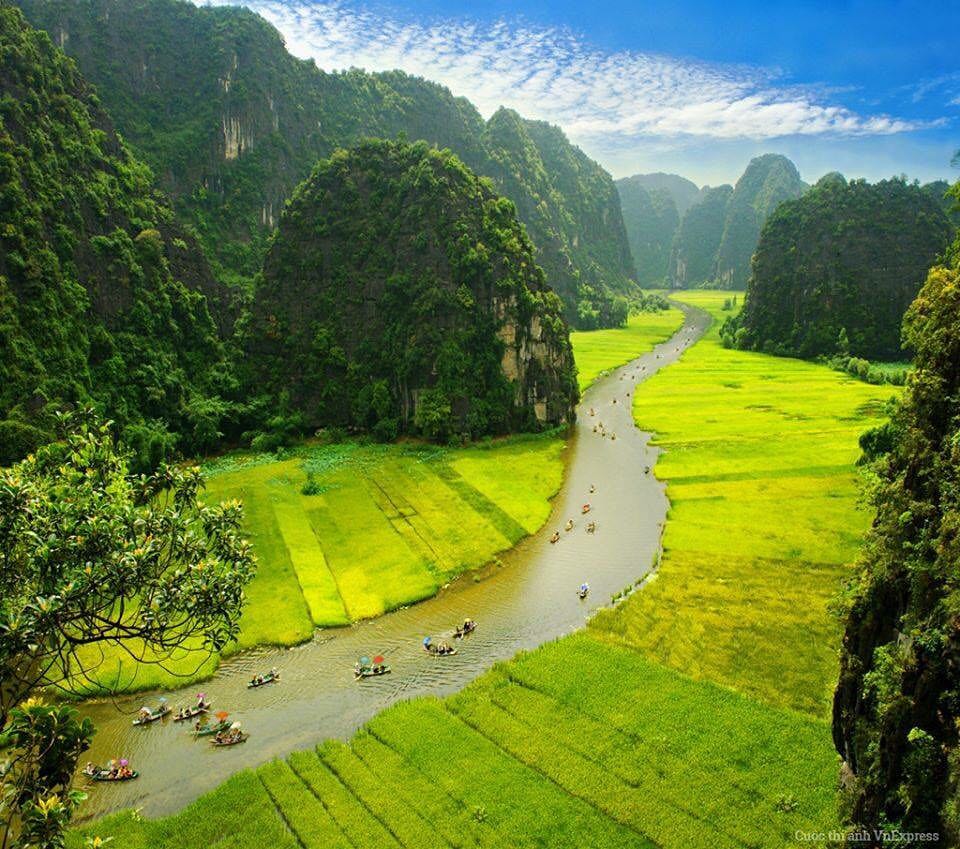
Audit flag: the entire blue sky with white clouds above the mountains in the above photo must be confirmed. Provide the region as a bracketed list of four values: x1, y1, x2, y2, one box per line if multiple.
[201, 0, 960, 185]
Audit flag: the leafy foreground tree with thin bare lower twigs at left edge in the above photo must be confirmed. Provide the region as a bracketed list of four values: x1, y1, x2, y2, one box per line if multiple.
[0, 411, 254, 849]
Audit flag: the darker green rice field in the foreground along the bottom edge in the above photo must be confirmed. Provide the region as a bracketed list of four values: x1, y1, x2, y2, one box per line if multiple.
[68, 633, 836, 849]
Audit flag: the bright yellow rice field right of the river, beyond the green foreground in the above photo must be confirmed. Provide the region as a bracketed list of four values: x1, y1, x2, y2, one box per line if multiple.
[593, 292, 898, 717]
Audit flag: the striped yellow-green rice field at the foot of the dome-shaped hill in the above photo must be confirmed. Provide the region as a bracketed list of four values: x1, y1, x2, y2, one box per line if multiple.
[76, 433, 564, 695]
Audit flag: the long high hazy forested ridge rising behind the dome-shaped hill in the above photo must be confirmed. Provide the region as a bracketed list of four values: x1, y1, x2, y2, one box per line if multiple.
[22, 0, 635, 327]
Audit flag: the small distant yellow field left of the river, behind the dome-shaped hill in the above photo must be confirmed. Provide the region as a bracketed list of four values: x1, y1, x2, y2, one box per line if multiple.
[570, 307, 683, 392]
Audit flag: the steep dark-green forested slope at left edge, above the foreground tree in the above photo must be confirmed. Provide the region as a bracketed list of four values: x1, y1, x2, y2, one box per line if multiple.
[0, 5, 229, 464]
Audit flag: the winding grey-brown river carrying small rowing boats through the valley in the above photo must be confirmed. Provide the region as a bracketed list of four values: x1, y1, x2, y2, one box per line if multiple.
[75, 308, 709, 819]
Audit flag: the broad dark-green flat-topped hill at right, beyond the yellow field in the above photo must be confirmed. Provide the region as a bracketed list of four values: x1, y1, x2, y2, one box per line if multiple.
[725, 175, 952, 360]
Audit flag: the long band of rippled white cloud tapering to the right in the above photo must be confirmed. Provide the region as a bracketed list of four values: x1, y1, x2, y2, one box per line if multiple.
[206, 0, 924, 152]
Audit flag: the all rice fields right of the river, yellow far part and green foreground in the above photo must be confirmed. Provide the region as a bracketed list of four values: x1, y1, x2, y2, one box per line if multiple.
[71, 292, 891, 849]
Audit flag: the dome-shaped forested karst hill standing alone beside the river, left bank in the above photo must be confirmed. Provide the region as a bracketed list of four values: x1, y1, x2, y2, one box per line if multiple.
[246, 141, 576, 438]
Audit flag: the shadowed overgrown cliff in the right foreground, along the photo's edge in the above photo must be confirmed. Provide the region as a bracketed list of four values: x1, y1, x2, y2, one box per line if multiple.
[833, 182, 960, 845]
